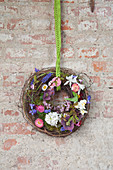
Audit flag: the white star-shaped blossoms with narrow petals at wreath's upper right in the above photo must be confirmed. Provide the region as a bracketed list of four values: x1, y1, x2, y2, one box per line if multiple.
[64, 75, 85, 95]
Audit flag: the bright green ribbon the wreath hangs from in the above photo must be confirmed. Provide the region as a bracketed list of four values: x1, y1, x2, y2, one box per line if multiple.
[54, 0, 61, 77]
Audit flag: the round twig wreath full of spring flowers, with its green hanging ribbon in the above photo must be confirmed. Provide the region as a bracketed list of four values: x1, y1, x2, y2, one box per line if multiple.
[22, 0, 91, 137]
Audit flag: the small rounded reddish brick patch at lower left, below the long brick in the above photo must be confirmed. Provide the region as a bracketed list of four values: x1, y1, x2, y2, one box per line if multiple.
[3, 139, 17, 151]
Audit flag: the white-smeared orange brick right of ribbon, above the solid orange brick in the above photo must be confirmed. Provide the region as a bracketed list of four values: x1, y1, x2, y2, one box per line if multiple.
[78, 48, 99, 58]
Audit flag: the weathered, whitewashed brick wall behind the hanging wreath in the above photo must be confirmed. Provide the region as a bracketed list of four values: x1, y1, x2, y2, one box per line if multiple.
[0, 0, 113, 170]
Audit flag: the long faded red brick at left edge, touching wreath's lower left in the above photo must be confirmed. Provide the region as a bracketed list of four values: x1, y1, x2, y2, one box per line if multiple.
[2, 123, 36, 135]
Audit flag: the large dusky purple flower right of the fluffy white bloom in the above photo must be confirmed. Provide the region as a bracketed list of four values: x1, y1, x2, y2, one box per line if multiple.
[61, 116, 74, 131]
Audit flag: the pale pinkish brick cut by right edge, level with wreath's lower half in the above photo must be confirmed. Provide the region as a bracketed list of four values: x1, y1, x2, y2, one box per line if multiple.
[104, 103, 113, 118]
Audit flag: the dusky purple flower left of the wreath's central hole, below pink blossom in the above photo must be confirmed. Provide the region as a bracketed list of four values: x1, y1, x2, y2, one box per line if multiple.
[43, 88, 55, 100]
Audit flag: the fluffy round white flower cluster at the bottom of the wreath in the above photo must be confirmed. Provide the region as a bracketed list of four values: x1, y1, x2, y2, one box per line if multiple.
[45, 112, 61, 127]
